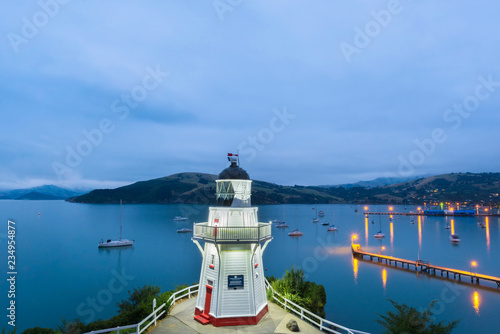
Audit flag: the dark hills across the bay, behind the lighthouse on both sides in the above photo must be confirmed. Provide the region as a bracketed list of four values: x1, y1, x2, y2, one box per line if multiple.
[68, 173, 500, 205]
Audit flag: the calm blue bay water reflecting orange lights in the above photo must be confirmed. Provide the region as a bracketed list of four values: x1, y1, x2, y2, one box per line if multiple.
[0, 200, 500, 333]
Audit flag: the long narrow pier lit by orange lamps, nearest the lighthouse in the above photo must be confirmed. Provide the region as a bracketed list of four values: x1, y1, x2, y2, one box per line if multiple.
[351, 243, 500, 288]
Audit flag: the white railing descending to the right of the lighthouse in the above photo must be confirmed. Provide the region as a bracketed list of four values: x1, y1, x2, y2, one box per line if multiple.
[265, 279, 369, 334]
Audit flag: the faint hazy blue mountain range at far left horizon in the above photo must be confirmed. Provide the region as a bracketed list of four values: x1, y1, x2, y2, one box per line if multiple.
[0, 185, 87, 200]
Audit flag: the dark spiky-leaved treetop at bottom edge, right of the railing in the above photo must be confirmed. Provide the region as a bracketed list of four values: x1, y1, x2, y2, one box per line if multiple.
[377, 299, 459, 334]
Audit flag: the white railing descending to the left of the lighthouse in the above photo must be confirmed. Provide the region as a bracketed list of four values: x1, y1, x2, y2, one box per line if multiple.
[85, 284, 199, 334]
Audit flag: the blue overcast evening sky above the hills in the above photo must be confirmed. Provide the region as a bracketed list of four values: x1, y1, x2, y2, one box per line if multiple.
[0, 0, 500, 188]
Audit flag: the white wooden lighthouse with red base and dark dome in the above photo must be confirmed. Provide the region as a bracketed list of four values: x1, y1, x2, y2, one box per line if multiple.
[192, 153, 272, 327]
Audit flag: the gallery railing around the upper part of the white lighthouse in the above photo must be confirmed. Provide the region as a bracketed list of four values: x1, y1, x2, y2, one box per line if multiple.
[193, 223, 272, 243]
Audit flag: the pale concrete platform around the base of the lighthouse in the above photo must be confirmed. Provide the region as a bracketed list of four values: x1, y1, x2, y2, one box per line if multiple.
[149, 298, 322, 334]
